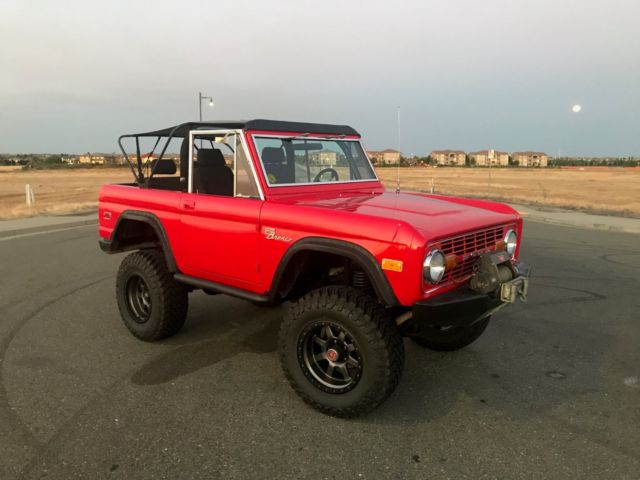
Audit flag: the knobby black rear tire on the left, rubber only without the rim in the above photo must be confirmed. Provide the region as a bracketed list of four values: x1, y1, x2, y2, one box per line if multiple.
[116, 250, 189, 342]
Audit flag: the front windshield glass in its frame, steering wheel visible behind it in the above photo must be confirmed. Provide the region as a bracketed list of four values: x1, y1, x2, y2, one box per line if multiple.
[254, 136, 377, 186]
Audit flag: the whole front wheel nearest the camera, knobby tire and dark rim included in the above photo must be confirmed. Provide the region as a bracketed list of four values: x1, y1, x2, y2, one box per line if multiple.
[278, 286, 404, 417]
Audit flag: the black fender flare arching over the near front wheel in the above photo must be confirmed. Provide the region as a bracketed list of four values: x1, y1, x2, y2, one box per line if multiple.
[269, 237, 399, 307]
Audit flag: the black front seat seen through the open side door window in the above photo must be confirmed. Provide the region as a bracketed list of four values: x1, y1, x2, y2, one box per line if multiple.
[193, 148, 233, 197]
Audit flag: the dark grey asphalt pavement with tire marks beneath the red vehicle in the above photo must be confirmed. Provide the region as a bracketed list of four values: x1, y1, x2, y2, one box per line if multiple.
[0, 223, 640, 480]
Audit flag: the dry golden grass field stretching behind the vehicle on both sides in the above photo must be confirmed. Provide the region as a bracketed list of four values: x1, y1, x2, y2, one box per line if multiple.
[0, 167, 640, 219]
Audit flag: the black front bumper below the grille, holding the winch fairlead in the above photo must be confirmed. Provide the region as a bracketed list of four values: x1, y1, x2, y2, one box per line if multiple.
[402, 262, 530, 335]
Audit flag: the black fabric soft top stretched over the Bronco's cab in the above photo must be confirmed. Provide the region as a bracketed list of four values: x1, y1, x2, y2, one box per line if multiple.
[130, 119, 359, 137]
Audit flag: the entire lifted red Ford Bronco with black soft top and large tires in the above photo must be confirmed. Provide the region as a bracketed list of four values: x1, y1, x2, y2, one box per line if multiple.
[99, 120, 528, 417]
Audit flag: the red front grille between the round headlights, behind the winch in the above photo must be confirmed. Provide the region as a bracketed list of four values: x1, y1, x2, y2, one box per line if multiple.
[433, 225, 508, 283]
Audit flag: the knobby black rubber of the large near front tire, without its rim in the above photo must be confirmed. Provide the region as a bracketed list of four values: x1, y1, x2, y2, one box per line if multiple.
[278, 286, 404, 417]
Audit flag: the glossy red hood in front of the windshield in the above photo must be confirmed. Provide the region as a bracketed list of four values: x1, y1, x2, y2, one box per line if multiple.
[279, 191, 518, 239]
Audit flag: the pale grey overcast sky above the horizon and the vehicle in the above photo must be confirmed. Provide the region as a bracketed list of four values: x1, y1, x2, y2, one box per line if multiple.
[0, 0, 640, 155]
